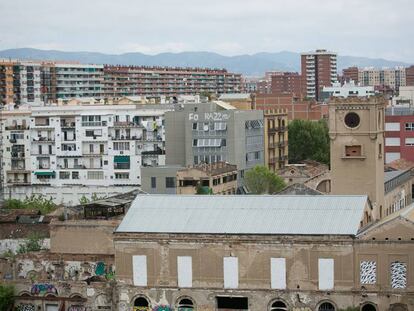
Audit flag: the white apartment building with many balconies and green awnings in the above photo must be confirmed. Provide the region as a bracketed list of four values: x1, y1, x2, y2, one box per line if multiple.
[2, 101, 173, 205]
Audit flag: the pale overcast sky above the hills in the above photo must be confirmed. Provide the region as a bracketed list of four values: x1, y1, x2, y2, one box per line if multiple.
[0, 0, 414, 62]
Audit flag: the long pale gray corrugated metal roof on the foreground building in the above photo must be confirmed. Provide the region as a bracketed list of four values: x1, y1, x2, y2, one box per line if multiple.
[116, 195, 367, 235]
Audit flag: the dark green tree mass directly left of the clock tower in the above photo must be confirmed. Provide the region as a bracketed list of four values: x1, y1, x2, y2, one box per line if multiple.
[288, 120, 329, 164]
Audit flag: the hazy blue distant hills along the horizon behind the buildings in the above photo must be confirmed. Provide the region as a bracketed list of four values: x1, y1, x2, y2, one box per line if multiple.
[0, 48, 410, 76]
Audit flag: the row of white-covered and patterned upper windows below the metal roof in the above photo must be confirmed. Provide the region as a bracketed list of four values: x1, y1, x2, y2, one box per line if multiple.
[132, 255, 407, 290]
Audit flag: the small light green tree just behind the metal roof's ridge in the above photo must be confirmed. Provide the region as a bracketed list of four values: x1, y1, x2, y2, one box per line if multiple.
[244, 165, 286, 194]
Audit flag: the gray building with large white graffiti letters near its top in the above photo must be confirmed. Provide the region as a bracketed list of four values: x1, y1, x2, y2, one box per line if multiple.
[165, 102, 264, 185]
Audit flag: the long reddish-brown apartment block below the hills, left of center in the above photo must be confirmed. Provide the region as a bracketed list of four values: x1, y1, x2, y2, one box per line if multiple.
[104, 65, 242, 98]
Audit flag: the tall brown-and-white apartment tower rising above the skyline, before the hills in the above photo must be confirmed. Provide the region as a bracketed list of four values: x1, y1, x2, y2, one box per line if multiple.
[301, 50, 337, 101]
